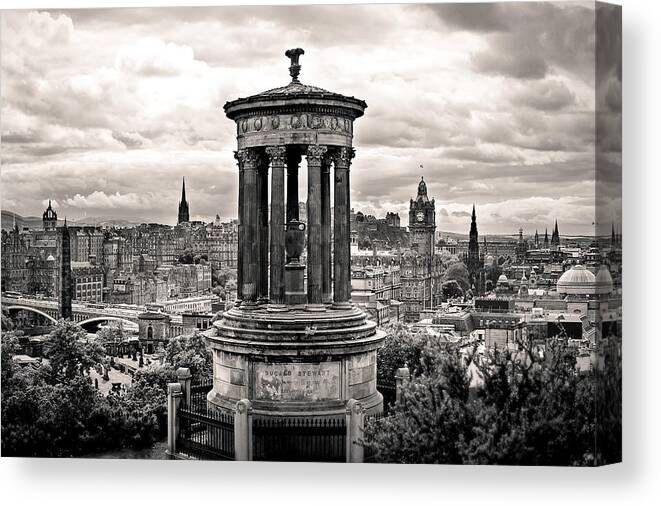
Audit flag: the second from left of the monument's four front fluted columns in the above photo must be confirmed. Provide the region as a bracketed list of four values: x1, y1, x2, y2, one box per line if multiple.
[266, 146, 286, 304]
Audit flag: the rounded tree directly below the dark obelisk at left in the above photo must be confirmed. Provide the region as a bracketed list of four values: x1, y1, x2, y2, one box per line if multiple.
[45, 320, 105, 380]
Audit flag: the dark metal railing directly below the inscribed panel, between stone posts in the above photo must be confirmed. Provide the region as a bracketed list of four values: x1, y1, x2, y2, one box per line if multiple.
[252, 417, 347, 462]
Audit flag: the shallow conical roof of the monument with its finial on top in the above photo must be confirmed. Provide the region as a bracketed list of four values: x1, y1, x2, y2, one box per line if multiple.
[224, 48, 367, 119]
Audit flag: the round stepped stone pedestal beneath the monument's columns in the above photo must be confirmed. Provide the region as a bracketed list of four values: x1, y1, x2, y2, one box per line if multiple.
[207, 307, 385, 417]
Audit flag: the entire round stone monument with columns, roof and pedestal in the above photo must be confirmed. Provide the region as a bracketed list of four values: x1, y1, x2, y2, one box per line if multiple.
[207, 48, 384, 419]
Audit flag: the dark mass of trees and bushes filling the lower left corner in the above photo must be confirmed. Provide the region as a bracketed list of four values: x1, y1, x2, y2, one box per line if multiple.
[0, 321, 168, 457]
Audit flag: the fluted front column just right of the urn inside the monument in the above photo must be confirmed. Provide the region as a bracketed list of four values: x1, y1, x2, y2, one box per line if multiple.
[307, 145, 327, 309]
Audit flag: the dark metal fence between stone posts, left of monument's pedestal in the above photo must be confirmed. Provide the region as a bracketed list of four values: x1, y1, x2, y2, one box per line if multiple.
[177, 384, 234, 460]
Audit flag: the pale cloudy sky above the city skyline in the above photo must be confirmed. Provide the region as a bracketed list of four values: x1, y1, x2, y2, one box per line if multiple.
[1, 2, 620, 234]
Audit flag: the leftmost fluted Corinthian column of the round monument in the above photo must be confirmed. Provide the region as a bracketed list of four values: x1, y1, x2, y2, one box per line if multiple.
[236, 148, 261, 304]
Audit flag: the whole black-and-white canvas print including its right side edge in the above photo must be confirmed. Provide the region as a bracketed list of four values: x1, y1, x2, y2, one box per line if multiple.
[1, 1, 623, 466]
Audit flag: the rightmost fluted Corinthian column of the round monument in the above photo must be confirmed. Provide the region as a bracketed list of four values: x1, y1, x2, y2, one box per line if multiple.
[333, 147, 355, 308]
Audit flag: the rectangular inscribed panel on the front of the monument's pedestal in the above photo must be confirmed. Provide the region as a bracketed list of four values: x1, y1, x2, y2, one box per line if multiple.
[253, 362, 340, 401]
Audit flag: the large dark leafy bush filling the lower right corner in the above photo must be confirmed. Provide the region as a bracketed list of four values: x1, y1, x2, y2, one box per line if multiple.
[365, 339, 621, 465]
